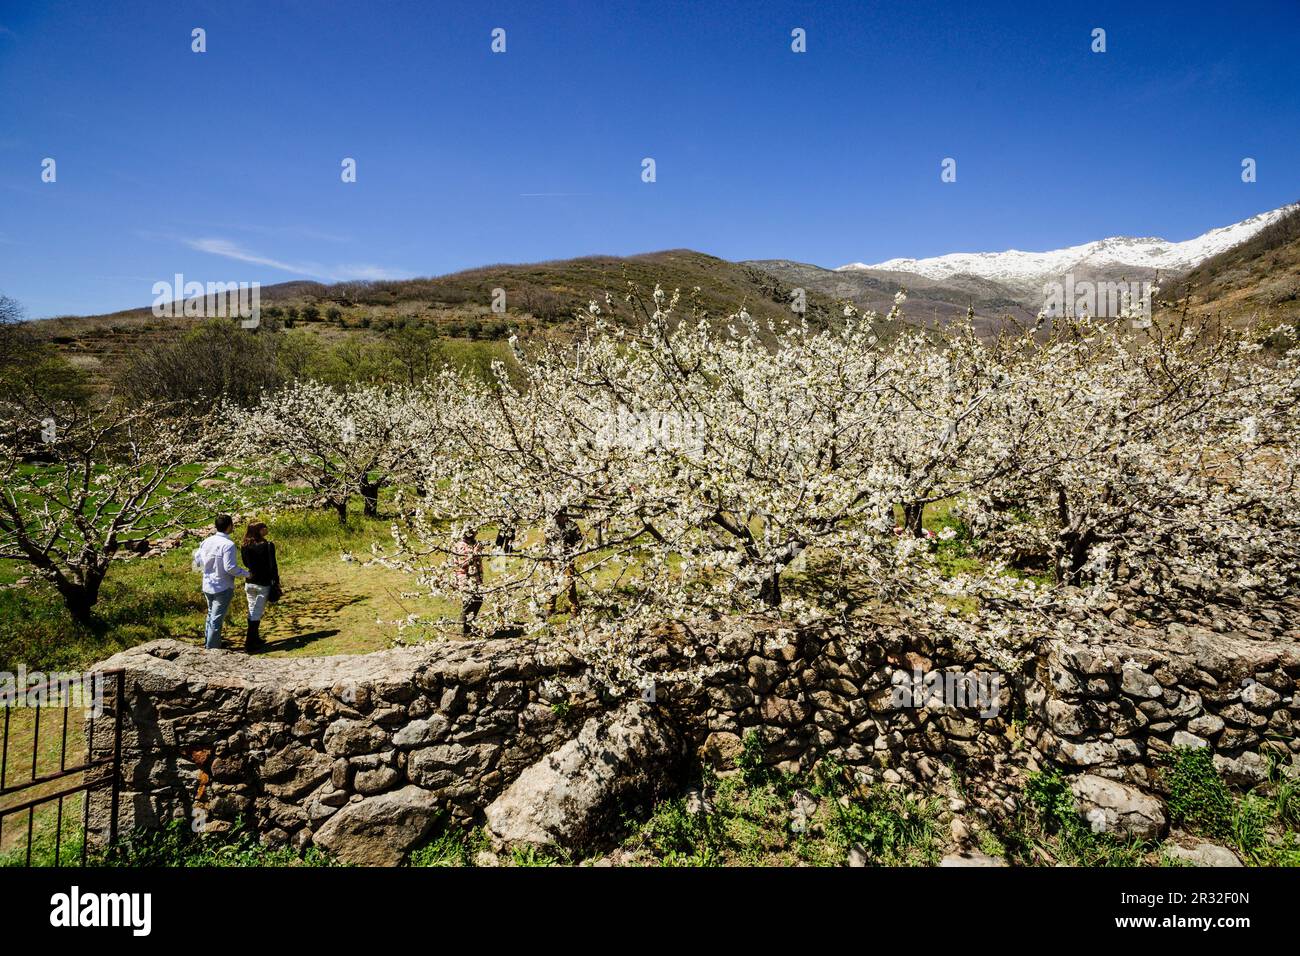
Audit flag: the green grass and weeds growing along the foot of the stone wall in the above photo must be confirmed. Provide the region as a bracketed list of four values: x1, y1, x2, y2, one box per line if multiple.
[0, 749, 1300, 868]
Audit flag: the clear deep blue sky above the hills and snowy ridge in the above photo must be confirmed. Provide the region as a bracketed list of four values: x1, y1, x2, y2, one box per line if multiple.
[0, 0, 1300, 316]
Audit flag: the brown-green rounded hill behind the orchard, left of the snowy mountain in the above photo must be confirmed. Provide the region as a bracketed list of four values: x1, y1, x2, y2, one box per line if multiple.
[31, 250, 842, 386]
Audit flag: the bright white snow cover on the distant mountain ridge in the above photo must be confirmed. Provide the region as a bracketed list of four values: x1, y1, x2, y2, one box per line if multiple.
[836, 204, 1300, 300]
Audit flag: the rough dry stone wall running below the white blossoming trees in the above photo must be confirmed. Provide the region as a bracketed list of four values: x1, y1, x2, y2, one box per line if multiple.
[92, 622, 1300, 864]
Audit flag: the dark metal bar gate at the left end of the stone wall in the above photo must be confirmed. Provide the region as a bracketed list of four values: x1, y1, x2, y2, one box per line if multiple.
[0, 670, 126, 866]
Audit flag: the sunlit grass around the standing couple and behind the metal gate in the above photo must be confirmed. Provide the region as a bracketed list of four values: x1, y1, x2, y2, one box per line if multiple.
[0, 502, 459, 861]
